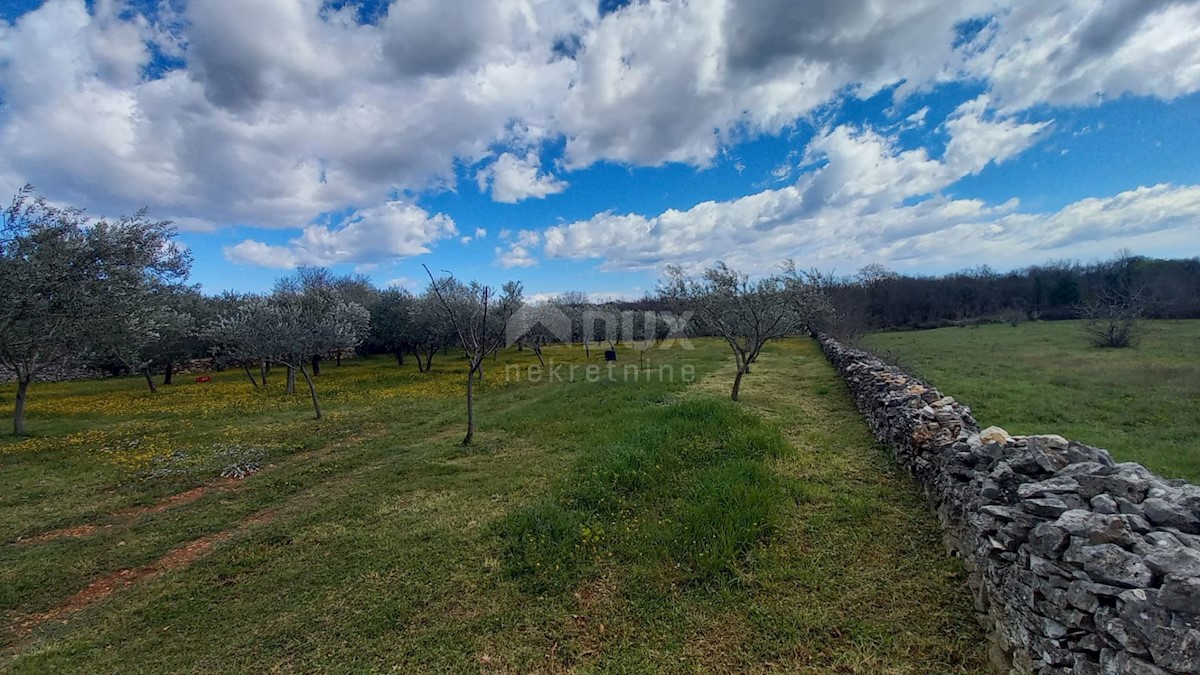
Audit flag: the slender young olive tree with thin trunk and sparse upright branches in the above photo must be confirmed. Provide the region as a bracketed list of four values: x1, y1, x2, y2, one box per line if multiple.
[425, 267, 522, 446]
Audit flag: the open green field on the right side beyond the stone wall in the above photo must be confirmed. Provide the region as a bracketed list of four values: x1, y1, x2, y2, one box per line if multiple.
[864, 321, 1200, 482]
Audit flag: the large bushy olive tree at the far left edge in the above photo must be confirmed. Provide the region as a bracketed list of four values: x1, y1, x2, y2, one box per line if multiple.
[0, 186, 191, 435]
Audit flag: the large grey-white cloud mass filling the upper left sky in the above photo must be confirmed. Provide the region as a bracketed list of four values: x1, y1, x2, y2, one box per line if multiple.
[0, 0, 580, 228]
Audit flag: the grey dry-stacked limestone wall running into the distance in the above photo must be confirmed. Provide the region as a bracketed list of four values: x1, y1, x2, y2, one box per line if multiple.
[821, 336, 1200, 674]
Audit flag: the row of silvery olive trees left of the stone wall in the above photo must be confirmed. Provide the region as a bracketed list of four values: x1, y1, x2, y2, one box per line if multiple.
[0, 187, 830, 443]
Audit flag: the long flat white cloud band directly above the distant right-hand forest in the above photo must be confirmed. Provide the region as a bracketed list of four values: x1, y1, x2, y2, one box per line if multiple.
[545, 176, 1200, 273]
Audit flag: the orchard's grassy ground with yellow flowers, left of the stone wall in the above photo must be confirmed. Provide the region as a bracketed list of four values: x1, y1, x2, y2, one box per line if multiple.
[0, 341, 985, 673]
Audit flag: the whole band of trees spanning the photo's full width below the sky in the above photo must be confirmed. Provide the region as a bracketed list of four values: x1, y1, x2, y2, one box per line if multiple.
[9, 187, 1176, 443]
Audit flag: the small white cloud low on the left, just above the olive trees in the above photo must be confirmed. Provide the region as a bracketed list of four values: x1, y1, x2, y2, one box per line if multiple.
[224, 202, 457, 269]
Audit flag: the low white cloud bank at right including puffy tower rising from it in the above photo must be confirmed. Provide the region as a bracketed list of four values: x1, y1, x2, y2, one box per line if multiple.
[544, 100, 1200, 271]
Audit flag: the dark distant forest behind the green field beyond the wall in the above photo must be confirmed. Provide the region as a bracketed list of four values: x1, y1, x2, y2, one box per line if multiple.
[806, 253, 1200, 333]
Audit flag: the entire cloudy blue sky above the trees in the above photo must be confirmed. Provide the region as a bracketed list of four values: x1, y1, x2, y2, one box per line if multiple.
[0, 0, 1200, 295]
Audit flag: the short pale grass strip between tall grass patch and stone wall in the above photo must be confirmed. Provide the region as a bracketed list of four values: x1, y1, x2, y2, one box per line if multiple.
[704, 341, 986, 673]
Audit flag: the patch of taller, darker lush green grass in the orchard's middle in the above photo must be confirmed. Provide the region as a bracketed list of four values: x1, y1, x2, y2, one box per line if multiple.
[499, 399, 790, 592]
